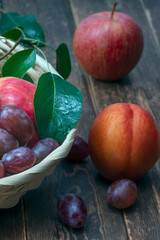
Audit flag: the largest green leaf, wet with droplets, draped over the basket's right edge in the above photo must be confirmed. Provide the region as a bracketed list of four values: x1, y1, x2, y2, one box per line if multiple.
[34, 73, 82, 142]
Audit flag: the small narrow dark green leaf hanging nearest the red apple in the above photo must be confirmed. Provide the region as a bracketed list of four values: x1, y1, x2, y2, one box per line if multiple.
[56, 43, 71, 79]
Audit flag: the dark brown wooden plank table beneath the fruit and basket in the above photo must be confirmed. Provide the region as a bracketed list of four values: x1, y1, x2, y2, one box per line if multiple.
[0, 0, 160, 240]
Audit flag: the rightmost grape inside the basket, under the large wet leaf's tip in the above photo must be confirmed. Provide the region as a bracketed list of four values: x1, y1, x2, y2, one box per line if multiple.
[32, 138, 59, 163]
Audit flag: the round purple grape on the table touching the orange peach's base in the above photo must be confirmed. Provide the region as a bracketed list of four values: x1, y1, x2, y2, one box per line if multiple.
[107, 179, 138, 209]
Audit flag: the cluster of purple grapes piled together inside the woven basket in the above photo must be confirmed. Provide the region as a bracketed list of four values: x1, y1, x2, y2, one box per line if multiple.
[0, 105, 59, 178]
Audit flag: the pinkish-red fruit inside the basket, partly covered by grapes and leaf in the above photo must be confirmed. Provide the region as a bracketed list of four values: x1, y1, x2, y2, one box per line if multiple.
[0, 77, 39, 147]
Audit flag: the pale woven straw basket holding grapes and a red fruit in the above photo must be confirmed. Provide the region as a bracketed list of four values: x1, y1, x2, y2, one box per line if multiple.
[0, 37, 76, 208]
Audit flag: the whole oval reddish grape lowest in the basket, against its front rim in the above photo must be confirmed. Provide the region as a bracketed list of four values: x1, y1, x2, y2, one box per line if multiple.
[2, 147, 36, 173]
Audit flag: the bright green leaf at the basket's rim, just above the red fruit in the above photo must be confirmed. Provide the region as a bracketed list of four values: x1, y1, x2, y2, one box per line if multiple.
[2, 49, 36, 78]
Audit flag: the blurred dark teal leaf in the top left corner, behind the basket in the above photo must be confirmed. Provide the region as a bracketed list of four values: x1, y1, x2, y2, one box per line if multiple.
[0, 12, 45, 45]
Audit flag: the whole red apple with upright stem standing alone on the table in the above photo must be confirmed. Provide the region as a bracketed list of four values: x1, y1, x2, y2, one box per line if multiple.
[73, 2, 144, 81]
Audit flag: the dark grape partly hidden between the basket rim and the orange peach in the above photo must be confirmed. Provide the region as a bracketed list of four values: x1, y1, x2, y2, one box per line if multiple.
[67, 136, 89, 161]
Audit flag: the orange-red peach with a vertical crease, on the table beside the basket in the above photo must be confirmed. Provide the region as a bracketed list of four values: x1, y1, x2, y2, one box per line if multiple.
[88, 103, 160, 181]
